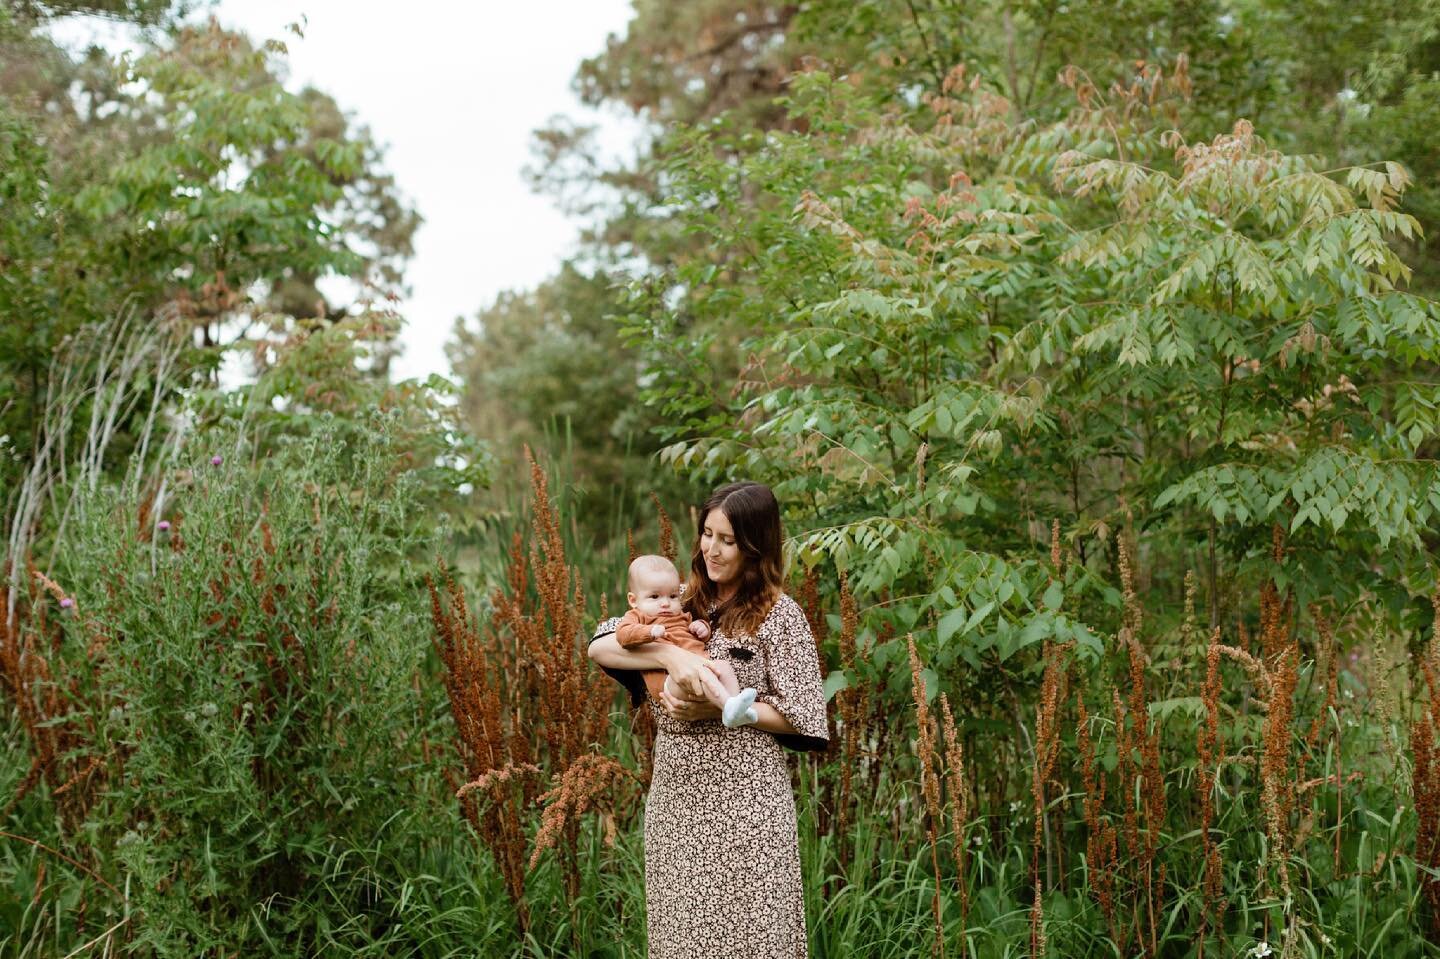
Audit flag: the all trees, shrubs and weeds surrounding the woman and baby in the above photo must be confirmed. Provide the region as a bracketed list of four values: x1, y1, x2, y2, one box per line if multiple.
[0, 0, 1440, 958]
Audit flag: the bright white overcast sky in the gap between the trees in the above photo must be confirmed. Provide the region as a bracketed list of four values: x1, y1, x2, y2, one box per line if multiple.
[58, 0, 639, 379]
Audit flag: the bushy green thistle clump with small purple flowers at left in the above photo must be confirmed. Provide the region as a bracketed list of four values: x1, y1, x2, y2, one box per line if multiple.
[46, 414, 425, 956]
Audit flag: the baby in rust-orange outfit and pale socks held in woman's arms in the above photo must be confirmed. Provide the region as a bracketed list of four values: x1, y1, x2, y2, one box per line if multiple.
[615, 556, 760, 727]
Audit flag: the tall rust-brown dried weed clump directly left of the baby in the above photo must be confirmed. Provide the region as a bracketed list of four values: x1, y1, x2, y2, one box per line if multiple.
[431, 449, 621, 926]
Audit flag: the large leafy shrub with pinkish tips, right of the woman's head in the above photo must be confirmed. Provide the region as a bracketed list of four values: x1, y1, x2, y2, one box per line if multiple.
[629, 63, 1440, 647]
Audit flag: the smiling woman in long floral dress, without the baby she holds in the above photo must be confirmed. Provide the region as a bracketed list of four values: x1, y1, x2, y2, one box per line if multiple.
[590, 482, 828, 959]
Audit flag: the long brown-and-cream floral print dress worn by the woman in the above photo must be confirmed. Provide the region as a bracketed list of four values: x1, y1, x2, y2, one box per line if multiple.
[595, 595, 828, 959]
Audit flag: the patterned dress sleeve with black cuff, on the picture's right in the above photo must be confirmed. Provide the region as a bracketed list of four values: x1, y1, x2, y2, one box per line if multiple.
[755, 596, 829, 752]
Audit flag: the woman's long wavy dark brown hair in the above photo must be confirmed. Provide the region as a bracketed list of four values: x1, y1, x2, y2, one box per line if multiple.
[685, 482, 785, 634]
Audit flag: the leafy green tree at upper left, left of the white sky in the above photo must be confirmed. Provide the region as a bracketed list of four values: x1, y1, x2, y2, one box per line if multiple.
[0, 14, 418, 501]
